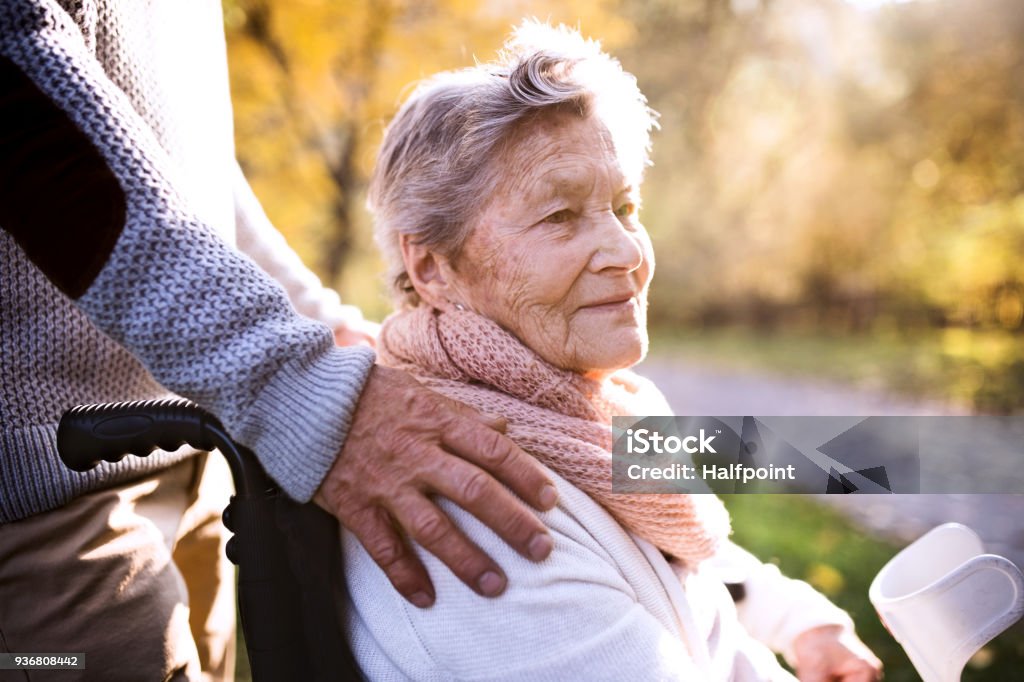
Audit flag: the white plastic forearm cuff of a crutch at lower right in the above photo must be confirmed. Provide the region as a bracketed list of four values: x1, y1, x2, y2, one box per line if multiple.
[868, 523, 1024, 682]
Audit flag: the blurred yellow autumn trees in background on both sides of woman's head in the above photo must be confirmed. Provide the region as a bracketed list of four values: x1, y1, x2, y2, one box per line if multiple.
[225, 0, 1024, 410]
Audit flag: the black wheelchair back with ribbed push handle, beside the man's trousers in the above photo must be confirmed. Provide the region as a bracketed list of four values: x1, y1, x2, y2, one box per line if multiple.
[57, 399, 364, 682]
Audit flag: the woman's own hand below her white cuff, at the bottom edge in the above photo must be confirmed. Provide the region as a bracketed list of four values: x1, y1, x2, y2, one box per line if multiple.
[793, 625, 882, 682]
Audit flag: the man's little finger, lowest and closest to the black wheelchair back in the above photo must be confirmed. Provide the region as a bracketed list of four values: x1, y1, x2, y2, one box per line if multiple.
[346, 499, 435, 608]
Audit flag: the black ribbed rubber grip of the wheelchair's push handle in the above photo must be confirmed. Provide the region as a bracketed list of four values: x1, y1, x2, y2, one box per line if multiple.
[57, 398, 222, 471]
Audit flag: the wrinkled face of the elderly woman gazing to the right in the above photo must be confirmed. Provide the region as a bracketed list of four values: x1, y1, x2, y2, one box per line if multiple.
[445, 115, 654, 378]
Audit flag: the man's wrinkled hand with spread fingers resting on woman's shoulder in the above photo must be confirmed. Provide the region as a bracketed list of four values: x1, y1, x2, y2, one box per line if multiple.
[313, 366, 557, 607]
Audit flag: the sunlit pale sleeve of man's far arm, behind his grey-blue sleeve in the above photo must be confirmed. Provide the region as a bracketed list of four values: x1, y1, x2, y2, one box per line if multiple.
[232, 158, 367, 330]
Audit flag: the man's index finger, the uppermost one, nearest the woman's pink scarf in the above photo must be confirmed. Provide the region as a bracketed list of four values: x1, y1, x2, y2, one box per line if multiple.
[443, 409, 558, 514]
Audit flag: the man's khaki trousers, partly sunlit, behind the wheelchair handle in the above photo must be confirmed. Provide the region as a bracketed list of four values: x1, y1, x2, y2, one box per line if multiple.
[0, 454, 234, 682]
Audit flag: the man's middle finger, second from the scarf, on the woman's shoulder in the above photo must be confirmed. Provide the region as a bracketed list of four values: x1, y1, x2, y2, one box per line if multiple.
[428, 456, 554, 561]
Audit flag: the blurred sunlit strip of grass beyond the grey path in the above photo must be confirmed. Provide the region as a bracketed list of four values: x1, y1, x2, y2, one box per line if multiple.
[651, 328, 1024, 414]
